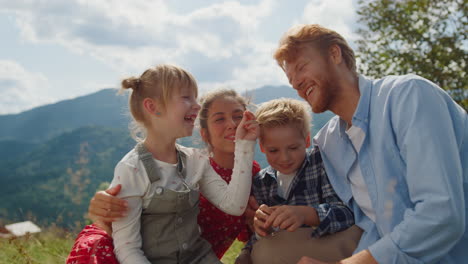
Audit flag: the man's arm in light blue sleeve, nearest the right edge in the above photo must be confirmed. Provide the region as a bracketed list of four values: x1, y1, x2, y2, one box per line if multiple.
[369, 80, 466, 263]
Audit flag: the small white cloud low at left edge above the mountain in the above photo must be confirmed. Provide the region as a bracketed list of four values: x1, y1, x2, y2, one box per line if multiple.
[0, 60, 54, 114]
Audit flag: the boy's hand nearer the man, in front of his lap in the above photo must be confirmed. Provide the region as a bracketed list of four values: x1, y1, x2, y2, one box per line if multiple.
[263, 205, 318, 232]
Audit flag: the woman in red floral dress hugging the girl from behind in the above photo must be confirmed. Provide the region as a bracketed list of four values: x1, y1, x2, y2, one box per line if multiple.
[67, 89, 260, 264]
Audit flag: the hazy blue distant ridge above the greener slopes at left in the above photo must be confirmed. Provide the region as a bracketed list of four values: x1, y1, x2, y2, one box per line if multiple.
[0, 89, 130, 143]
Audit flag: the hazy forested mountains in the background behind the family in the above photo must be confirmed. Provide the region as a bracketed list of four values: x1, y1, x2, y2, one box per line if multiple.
[0, 86, 332, 228]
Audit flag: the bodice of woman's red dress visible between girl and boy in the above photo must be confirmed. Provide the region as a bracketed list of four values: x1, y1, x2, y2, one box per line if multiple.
[198, 158, 260, 259]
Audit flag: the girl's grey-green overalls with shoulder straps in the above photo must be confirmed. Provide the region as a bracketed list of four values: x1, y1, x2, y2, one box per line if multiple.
[135, 143, 221, 264]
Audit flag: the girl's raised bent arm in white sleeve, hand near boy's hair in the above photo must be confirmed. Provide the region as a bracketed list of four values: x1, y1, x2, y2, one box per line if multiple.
[199, 111, 260, 215]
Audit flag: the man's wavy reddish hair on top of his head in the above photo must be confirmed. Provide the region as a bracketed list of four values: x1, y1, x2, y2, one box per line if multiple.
[273, 24, 357, 74]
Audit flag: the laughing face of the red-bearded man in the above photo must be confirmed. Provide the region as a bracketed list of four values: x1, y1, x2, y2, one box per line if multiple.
[285, 46, 337, 113]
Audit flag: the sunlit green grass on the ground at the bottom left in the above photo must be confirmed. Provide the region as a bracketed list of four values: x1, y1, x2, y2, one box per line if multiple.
[0, 228, 243, 264]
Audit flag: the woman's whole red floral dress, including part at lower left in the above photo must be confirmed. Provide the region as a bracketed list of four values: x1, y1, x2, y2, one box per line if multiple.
[66, 159, 260, 264]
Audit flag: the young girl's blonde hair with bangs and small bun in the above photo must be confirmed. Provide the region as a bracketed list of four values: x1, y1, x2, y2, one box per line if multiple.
[121, 64, 198, 140]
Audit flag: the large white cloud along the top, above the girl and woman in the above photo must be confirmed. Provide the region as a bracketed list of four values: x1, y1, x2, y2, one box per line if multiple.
[0, 0, 272, 71]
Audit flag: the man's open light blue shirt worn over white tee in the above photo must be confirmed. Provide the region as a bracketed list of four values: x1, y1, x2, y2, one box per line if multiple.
[314, 75, 468, 264]
